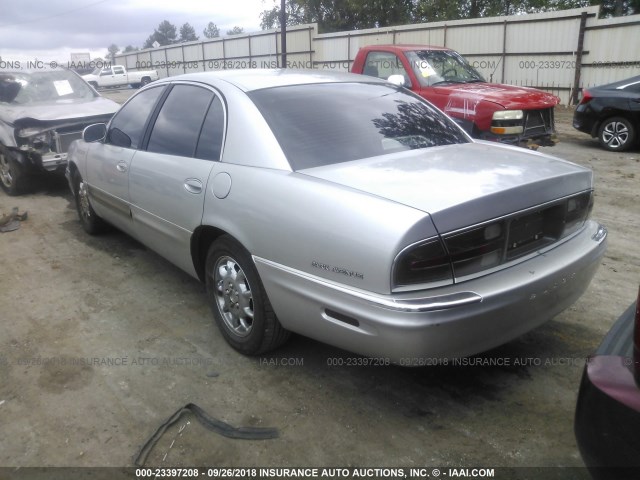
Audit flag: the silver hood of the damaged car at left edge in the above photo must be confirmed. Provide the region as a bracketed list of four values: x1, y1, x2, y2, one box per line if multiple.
[0, 97, 120, 124]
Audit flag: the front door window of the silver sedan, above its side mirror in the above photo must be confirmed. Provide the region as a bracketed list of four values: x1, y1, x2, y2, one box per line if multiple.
[106, 87, 164, 148]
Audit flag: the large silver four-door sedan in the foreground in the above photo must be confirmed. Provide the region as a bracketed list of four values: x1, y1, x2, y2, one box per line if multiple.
[67, 70, 607, 365]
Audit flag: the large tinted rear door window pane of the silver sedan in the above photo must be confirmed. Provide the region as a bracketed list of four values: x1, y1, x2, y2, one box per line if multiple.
[147, 85, 214, 157]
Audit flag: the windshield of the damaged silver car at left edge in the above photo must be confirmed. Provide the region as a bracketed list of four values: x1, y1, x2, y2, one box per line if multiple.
[0, 70, 96, 105]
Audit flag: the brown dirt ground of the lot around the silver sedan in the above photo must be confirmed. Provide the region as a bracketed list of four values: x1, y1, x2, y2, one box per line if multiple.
[0, 92, 640, 478]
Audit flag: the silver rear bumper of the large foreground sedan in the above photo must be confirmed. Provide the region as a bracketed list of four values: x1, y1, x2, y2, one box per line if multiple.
[254, 221, 606, 365]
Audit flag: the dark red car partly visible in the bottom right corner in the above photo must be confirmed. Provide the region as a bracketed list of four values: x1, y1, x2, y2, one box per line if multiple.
[575, 291, 640, 480]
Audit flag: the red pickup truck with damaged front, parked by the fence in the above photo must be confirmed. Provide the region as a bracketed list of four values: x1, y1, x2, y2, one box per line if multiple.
[351, 45, 560, 146]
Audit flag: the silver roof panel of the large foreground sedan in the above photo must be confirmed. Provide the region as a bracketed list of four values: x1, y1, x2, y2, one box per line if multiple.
[154, 68, 387, 92]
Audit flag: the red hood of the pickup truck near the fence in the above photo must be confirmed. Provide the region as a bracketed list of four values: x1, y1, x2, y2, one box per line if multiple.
[434, 82, 560, 110]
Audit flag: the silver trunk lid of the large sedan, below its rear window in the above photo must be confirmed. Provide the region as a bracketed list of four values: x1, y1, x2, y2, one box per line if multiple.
[298, 142, 592, 233]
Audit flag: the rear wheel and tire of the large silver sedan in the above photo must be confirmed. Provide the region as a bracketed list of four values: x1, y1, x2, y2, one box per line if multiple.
[205, 235, 290, 355]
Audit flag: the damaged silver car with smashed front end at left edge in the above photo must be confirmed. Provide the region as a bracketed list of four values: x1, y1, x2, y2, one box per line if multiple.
[0, 69, 119, 195]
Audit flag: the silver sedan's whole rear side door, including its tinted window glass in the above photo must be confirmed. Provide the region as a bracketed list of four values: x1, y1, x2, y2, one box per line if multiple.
[129, 83, 225, 273]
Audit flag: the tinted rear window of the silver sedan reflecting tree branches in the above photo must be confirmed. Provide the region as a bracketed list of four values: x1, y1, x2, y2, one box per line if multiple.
[249, 83, 469, 170]
